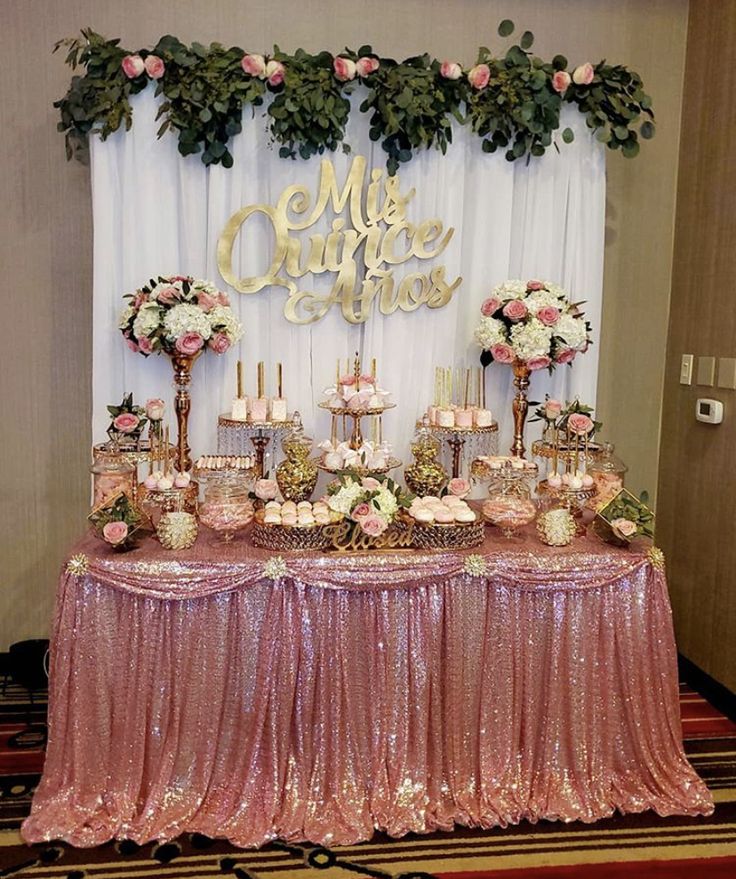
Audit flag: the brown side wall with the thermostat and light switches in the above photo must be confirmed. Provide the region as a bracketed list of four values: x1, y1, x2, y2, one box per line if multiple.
[657, 0, 736, 692]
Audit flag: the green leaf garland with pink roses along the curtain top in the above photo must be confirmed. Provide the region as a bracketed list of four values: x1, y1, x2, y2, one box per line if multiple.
[54, 20, 655, 174]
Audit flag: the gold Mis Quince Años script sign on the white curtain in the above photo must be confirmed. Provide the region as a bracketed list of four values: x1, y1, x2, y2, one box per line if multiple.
[217, 156, 462, 324]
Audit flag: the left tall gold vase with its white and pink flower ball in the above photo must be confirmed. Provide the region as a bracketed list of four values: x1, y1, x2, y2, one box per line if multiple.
[119, 275, 243, 472]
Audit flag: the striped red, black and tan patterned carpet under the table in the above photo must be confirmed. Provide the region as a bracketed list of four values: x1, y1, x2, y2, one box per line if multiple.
[0, 685, 736, 879]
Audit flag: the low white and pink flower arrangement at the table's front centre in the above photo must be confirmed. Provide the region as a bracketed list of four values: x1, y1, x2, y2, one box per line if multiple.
[327, 471, 414, 537]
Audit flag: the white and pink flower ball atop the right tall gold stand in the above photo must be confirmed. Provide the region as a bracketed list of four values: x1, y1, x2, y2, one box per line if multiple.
[474, 280, 592, 371]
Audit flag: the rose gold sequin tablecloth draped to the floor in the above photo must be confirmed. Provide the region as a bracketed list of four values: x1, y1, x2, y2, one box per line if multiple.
[23, 532, 713, 846]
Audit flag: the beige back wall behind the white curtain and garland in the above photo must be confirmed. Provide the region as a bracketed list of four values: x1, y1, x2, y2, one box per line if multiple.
[0, 0, 687, 647]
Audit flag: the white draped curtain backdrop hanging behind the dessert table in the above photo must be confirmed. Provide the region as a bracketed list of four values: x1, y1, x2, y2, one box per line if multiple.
[92, 90, 605, 474]
